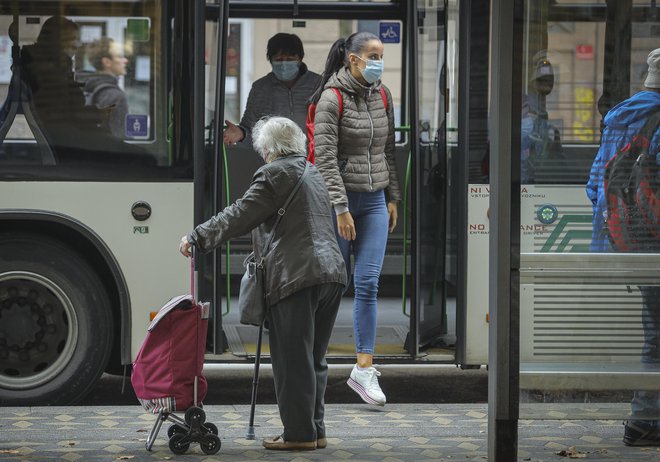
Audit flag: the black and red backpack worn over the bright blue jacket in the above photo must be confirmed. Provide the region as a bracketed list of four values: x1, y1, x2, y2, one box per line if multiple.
[603, 113, 660, 252]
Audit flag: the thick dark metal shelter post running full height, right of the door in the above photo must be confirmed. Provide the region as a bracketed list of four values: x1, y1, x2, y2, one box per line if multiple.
[488, 0, 523, 462]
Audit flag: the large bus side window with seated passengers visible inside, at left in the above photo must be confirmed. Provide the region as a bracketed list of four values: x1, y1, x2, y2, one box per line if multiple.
[0, 1, 182, 180]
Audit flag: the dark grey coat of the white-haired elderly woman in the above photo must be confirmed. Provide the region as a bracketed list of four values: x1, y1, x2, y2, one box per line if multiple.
[189, 155, 347, 305]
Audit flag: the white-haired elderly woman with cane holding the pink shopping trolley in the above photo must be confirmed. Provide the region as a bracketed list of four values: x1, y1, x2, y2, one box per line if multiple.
[179, 117, 347, 449]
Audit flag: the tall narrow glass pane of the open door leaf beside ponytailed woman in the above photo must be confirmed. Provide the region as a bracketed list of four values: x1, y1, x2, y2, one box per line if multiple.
[416, 2, 458, 352]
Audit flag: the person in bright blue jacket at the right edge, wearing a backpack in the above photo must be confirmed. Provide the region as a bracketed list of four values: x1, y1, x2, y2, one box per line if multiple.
[587, 48, 660, 446]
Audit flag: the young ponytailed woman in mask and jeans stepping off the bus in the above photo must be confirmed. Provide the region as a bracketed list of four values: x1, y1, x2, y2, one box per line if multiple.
[310, 32, 401, 406]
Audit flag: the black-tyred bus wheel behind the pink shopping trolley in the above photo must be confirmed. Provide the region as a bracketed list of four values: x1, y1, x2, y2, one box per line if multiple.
[0, 234, 112, 406]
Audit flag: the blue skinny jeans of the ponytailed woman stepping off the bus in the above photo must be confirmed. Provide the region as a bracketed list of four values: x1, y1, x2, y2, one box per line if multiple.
[335, 191, 389, 354]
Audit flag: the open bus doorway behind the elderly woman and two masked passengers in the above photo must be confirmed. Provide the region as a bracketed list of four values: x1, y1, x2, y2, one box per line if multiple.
[203, 1, 447, 361]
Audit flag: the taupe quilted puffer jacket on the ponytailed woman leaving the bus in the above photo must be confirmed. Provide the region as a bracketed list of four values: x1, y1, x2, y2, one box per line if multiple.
[314, 67, 401, 213]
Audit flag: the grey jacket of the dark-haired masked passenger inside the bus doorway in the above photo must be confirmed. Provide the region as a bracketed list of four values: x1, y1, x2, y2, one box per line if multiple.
[239, 63, 321, 146]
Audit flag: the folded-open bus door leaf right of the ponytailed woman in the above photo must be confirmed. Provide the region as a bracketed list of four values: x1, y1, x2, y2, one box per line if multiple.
[404, 2, 456, 361]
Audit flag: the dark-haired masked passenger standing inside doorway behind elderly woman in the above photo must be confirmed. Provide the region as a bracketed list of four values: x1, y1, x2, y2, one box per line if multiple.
[223, 32, 321, 146]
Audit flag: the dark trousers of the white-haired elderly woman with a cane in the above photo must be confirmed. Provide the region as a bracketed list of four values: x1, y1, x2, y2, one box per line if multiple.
[268, 283, 344, 442]
